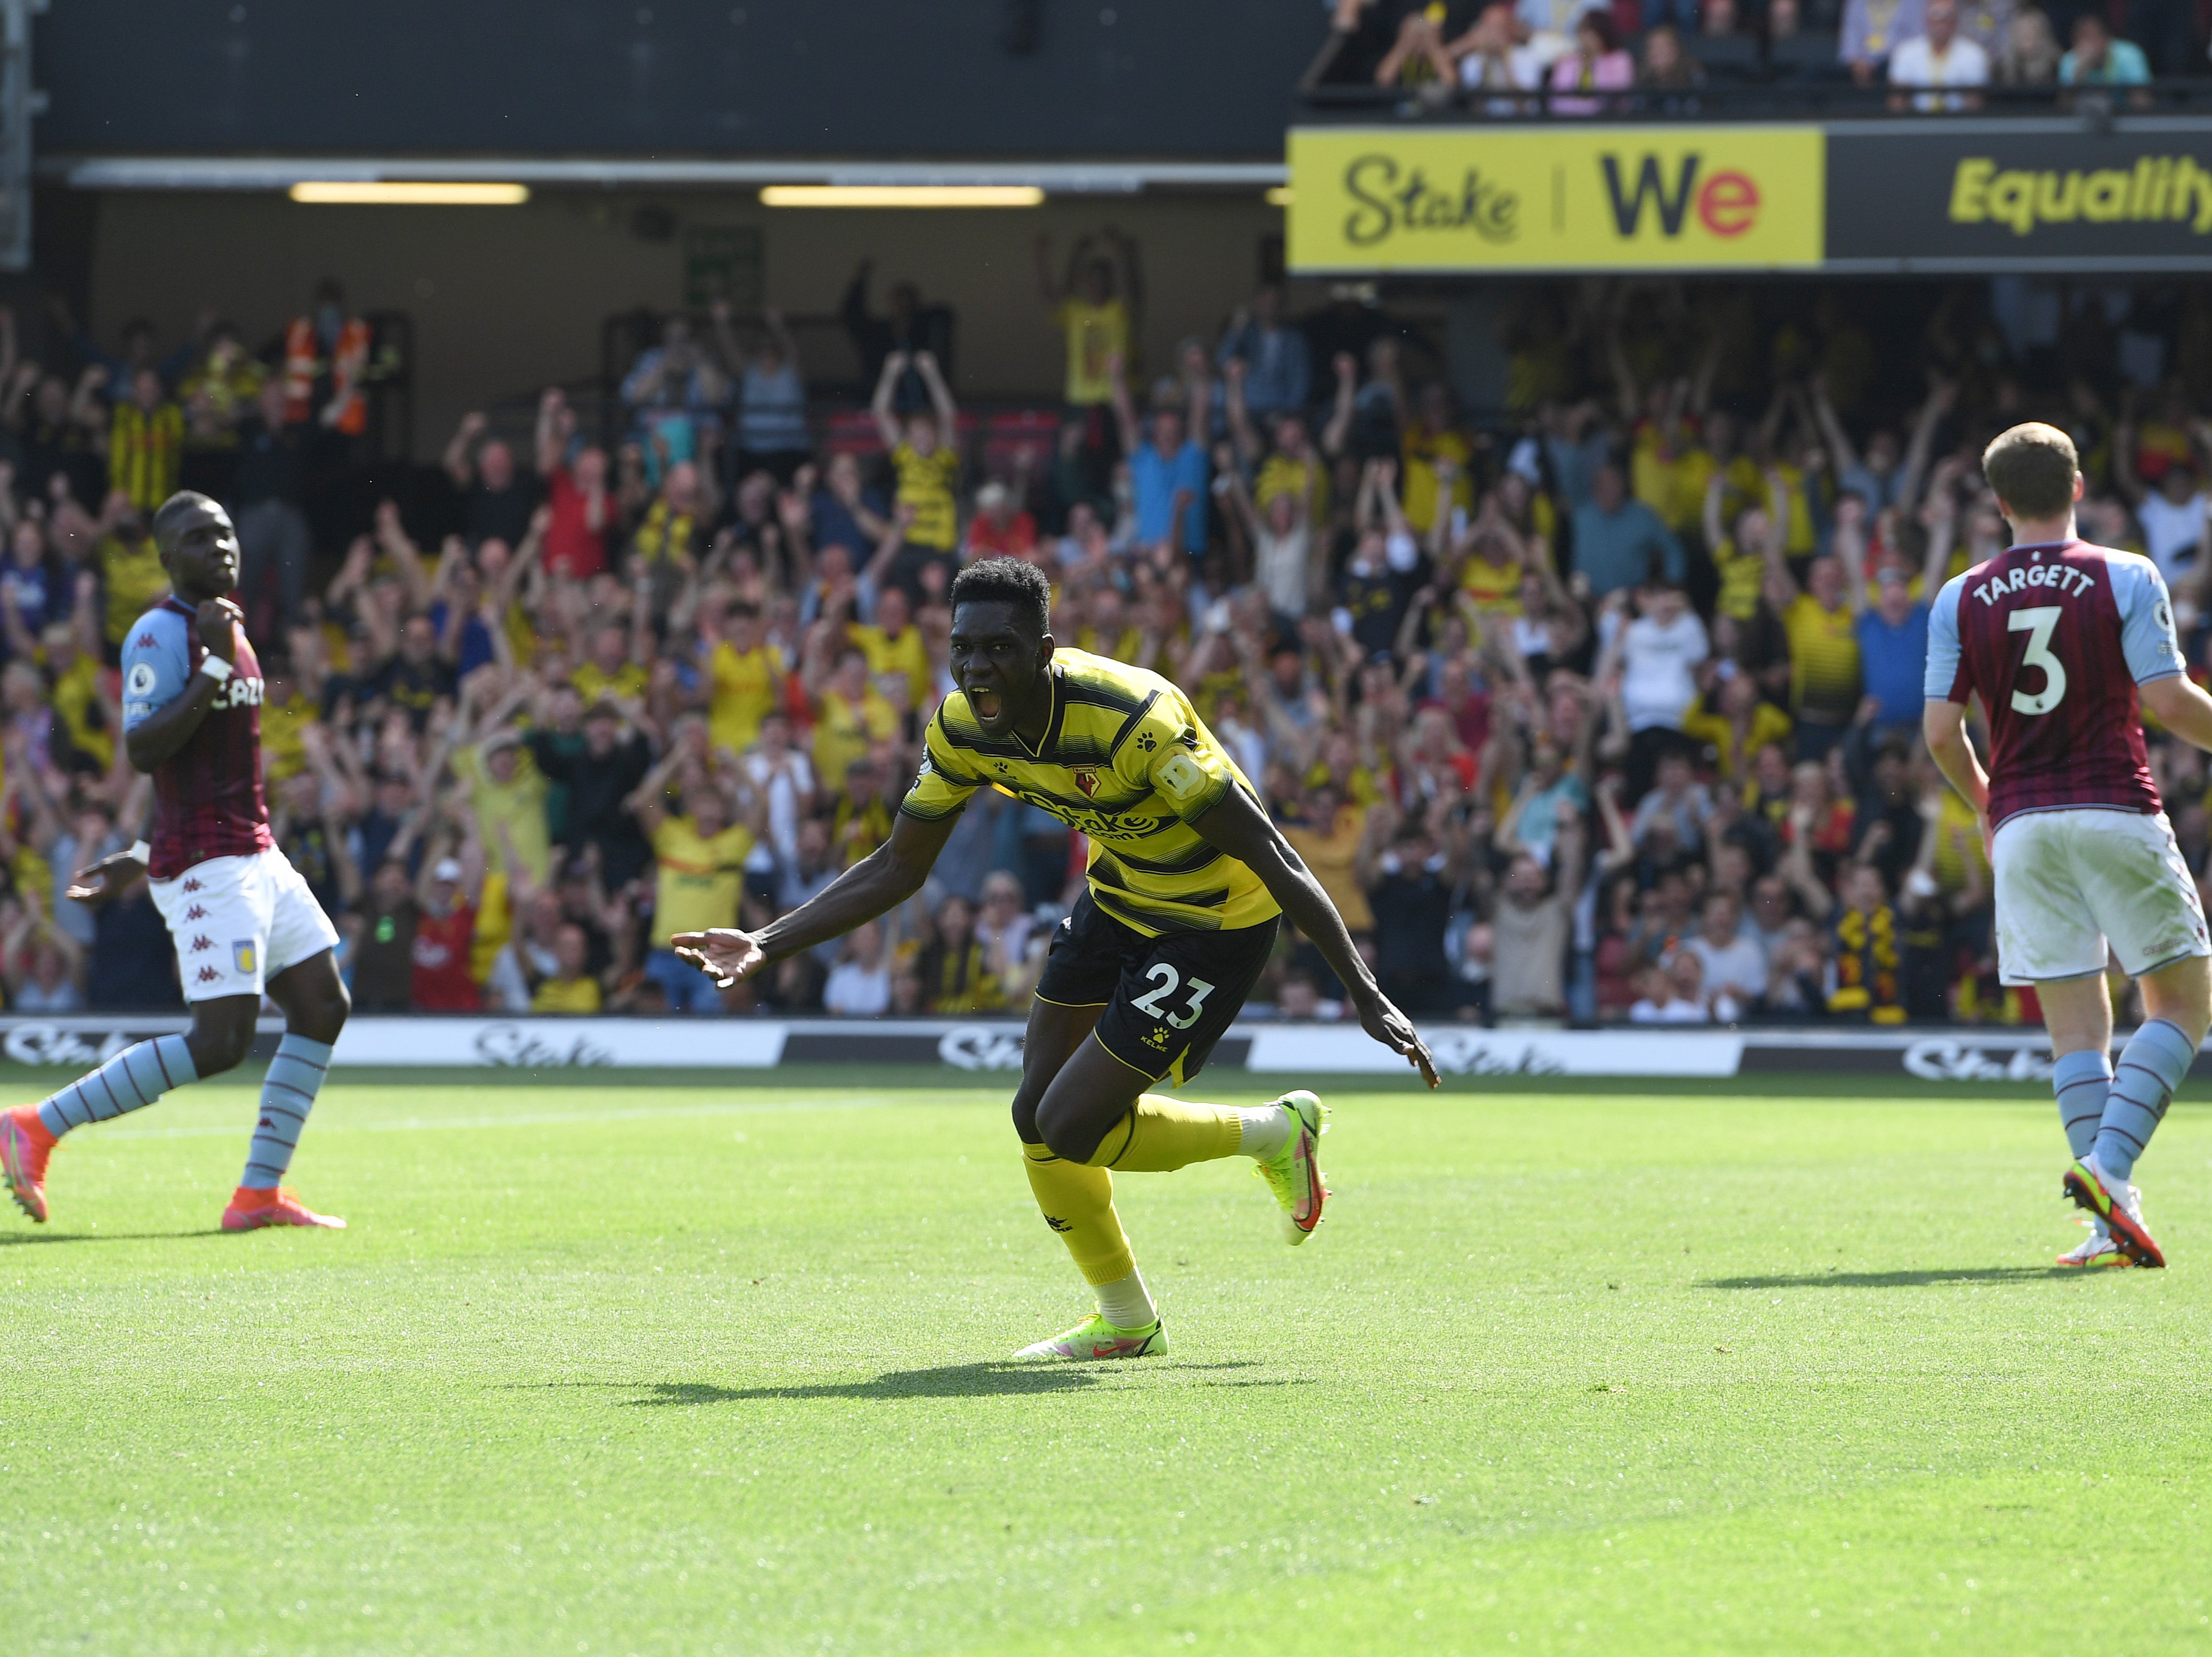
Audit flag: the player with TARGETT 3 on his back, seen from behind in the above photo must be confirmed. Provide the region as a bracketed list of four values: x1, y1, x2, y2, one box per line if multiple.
[1925, 425, 2212, 1265]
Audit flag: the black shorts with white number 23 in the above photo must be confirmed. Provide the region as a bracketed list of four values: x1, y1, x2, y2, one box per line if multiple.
[1037, 892, 1278, 1086]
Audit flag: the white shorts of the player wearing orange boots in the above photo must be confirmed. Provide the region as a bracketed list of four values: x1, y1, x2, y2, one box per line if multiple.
[148, 852, 339, 1002]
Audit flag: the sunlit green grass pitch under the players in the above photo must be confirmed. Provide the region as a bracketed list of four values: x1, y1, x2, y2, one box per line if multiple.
[0, 1073, 2212, 1657]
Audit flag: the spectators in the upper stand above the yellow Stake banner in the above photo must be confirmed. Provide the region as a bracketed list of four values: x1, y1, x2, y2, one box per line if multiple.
[1323, 0, 2206, 98]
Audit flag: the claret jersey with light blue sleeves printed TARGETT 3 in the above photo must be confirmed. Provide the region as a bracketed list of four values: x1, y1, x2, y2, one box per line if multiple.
[1925, 540, 2188, 827]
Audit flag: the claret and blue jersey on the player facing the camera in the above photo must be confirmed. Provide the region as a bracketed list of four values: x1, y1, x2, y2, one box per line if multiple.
[124, 597, 277, 880]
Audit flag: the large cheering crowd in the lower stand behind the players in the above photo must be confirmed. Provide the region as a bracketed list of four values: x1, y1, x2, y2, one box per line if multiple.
[0, 266, 2212, 1024]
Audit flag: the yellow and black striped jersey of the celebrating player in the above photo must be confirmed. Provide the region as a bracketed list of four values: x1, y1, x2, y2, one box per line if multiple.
[900, 650, 1281, 938]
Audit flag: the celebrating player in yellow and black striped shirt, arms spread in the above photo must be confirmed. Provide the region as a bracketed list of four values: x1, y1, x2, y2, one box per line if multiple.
[670, 557, 1435, 1361]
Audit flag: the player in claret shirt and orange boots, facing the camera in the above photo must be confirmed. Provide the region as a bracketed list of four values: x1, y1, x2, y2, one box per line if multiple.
[0, 491, 347, 1230]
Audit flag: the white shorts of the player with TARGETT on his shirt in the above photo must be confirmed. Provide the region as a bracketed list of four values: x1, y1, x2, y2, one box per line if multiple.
[1993, 807, 2212, 985]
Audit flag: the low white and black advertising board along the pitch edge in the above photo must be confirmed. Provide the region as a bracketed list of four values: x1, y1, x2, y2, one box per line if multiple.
[0, 1013, 2212, 1093]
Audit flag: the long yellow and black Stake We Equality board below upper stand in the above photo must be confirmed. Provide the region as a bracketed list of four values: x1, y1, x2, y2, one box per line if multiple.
[1290, 117, 2212, 274]
